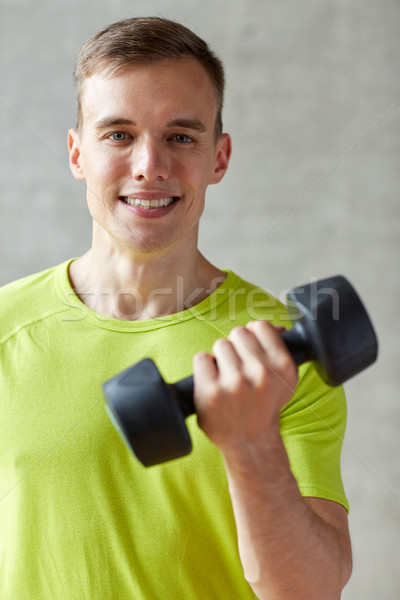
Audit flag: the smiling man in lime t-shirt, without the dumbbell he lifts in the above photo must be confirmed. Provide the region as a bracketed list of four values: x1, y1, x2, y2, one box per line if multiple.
[0, 18, 351, 600]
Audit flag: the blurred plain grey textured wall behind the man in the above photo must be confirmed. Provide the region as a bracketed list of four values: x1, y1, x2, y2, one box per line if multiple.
[0, 0, 400, 600]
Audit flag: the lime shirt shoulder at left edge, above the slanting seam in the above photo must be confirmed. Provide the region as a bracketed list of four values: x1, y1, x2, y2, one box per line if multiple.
[0, 261, 69, 343]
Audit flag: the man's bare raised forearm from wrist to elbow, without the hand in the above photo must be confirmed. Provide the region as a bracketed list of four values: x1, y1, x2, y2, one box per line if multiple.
[225, 435, 349, 600]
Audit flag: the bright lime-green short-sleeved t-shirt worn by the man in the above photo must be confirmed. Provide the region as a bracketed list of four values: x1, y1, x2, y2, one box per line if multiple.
[0, 263, 347, 600]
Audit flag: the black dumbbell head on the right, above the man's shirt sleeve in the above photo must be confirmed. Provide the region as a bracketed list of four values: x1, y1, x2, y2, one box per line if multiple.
[282, 275, 378, 386]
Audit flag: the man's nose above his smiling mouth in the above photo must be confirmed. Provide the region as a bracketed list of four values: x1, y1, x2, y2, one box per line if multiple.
[132, 138, 169, 182]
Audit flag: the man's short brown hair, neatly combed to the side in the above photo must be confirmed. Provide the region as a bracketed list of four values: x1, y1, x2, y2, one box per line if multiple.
[74, 17, 225, 137]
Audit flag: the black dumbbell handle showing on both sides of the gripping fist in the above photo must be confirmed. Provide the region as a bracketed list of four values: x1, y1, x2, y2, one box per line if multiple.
[168, 324, 314, 419]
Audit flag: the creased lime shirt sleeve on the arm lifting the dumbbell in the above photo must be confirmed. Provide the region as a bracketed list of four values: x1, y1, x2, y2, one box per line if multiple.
[281, 363, 349, 510]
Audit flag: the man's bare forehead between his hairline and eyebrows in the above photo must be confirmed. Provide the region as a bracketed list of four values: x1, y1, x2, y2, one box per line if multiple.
[80, 57, 217, 125]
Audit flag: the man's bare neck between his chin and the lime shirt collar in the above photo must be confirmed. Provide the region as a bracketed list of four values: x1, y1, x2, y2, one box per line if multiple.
[69, 230, 225, 320]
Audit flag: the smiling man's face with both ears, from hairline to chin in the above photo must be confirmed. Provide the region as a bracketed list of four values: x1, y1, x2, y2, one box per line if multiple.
[69, 58, 230, 252]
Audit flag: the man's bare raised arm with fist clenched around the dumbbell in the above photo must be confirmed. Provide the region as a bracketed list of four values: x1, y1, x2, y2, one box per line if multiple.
[194, 322, 351, 600]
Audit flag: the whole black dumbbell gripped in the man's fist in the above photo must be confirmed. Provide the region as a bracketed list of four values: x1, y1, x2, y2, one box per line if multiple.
[103, 275, 378, 467]
